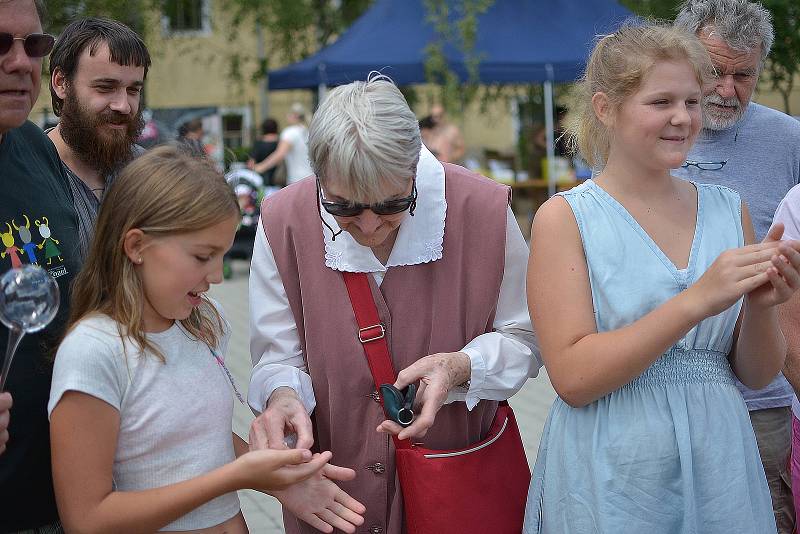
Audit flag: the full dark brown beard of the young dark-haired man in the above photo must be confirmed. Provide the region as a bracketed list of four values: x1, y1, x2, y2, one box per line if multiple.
[59, 86, 144, 177]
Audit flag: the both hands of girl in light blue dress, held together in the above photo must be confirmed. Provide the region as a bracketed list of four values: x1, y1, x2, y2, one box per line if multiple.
[688, 224, 800, 321]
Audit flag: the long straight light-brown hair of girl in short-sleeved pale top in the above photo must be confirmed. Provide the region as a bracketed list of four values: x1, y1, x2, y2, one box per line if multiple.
[67, 146, 239, 361]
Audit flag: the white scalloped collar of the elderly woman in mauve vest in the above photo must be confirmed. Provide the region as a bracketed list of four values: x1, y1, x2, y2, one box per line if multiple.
[320, 145, 447, 273]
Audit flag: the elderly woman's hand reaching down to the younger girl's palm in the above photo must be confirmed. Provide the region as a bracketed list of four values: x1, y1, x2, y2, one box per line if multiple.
[249, 387, 314, 451]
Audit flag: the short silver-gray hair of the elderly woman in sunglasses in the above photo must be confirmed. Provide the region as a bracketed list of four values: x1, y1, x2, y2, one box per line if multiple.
[308, 73, 422, 203]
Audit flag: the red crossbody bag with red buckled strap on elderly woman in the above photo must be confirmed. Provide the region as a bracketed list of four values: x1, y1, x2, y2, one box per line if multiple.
[342, 272, 531, 534]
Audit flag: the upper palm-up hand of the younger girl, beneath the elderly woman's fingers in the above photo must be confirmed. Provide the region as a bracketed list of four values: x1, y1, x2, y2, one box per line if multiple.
[236, 449, 332, 492]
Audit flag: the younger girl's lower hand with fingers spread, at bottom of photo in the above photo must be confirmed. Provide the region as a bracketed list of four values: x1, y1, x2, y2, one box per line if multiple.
[270, 455, 367, 532]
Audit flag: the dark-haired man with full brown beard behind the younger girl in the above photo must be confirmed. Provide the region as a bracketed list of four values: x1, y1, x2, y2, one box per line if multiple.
[48, 18, 150, 257]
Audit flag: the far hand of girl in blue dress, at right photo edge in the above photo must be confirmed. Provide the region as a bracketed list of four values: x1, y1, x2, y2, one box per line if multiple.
[747, 223, 800, 308]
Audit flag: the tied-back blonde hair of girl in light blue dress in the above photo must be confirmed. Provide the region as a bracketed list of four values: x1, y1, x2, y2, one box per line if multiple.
[567, 22, 713, 168]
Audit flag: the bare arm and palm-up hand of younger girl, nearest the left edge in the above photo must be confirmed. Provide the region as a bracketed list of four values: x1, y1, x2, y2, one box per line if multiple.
[50, 391, 330, 534]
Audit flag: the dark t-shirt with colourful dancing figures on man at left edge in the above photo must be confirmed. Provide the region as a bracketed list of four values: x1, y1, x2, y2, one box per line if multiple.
[0, 122, 80, 533]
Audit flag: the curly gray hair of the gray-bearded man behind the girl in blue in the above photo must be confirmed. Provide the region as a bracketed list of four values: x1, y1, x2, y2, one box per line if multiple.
[675, 0, 775, 65]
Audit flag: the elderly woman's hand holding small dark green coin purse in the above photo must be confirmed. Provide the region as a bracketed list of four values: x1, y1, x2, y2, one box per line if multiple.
[377, 352, 472, 439]
